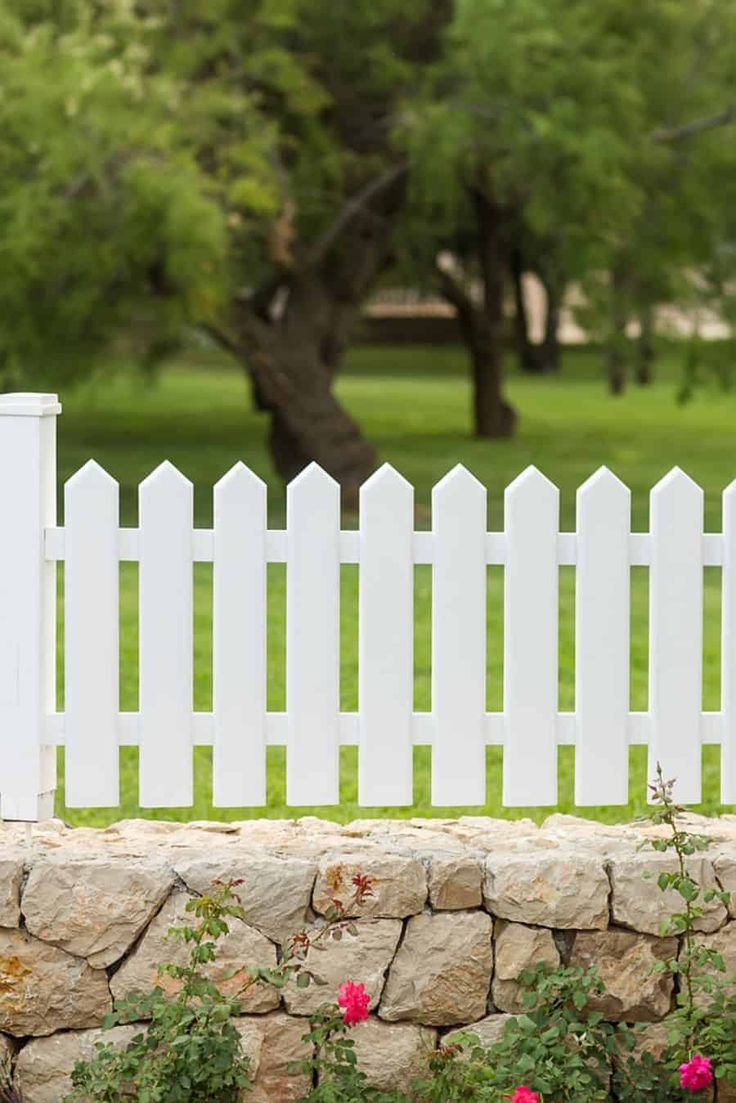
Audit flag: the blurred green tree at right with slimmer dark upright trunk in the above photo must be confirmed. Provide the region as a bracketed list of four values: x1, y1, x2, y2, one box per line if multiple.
[403, 0, 736, 437]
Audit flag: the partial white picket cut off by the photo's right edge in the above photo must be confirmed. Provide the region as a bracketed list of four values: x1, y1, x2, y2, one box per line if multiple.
[721, 480, 736, 804]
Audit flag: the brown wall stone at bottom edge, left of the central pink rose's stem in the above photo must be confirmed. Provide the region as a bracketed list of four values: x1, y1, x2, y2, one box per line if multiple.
[239, 1011, 309, 1103]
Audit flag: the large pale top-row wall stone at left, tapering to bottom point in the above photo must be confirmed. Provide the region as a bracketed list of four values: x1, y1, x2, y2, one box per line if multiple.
[22, 858, 174, 968]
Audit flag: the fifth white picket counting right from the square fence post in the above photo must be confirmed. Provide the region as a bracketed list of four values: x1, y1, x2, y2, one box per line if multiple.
[358, 463, 414, 805]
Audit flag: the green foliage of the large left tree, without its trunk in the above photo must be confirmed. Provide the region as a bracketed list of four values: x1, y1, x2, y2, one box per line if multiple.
[0, 0, 443, 386]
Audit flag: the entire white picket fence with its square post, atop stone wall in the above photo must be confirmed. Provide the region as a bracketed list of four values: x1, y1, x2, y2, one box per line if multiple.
[0, 395, 736, 820]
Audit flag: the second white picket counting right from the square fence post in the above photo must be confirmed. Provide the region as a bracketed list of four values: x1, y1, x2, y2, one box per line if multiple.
[139, 462, 193, 807]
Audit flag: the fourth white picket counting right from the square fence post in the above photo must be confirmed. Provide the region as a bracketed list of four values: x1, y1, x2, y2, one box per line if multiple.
[286, 463, 340, 805]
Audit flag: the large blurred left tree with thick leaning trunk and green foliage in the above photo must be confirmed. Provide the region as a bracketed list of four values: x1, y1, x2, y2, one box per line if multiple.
[0, 0, 447, 488]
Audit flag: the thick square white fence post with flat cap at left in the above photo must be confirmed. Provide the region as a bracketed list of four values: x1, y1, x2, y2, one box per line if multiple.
[0, 394, 61, 821]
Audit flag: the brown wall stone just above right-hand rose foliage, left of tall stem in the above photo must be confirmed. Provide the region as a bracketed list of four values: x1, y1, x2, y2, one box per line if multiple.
[569, 929, 678, 1022]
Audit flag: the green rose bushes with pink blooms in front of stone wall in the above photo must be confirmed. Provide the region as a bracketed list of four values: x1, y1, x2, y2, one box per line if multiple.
[64, 771, 736, 1103]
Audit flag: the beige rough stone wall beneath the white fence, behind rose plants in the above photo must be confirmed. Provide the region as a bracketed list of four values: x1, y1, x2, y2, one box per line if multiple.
[0, 815, 736, 1103]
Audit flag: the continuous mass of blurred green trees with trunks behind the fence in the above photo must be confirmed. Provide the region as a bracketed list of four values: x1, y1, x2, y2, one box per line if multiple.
[0, 0, 736, 474]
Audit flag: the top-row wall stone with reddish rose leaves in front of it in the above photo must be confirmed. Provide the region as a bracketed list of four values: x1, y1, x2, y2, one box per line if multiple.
[312, 854, 427, 919]
